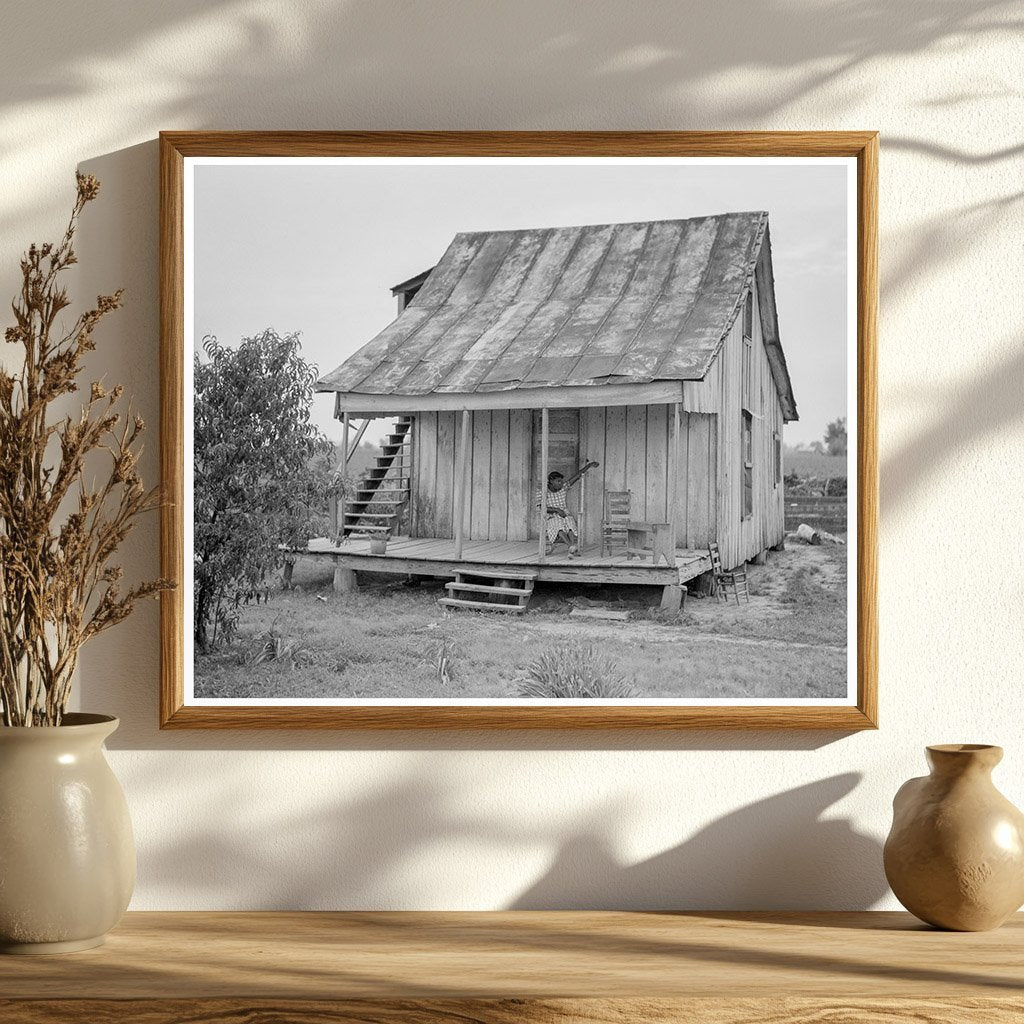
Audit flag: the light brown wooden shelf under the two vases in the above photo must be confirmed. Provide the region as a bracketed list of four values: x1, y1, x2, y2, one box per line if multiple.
[0, 911, 1024, 1024]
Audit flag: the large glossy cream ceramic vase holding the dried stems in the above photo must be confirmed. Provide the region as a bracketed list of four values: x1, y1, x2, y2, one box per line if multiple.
[0, 714, 135, 953]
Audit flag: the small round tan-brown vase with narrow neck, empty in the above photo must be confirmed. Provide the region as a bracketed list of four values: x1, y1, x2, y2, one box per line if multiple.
[885, 743, 1024, 932]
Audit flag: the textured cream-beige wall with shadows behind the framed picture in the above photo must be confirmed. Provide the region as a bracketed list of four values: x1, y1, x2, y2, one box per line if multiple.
[0, 0, 1024, 908]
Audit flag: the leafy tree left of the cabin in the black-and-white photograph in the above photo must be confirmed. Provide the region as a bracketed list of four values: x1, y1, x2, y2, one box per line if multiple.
[194, 329, 333, 650]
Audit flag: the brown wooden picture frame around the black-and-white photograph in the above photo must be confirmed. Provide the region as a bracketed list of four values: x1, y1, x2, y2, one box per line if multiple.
[160, 131, 879, 730]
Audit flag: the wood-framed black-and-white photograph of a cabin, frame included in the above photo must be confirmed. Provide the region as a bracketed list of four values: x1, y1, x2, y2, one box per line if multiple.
[160, 132, 878, 730]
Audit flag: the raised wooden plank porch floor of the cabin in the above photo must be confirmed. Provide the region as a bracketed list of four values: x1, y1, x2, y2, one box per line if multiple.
[304, 537, 711, 586]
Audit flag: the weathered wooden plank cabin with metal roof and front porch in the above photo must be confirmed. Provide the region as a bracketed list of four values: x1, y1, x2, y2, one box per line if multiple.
[317, 212, 797, 598]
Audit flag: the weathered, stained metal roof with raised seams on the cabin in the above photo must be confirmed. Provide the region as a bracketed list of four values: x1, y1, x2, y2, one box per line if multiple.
[317, 212, 792, 413]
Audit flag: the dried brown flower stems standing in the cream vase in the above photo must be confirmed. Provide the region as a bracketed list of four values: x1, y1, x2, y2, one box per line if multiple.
[0, 173, 170, 726]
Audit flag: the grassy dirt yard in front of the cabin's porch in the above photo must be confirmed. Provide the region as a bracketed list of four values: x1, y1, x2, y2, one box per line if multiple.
[196, 541, 847, 699]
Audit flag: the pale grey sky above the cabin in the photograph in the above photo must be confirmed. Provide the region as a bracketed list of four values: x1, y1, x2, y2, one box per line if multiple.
[194, 159, 848, 444]
